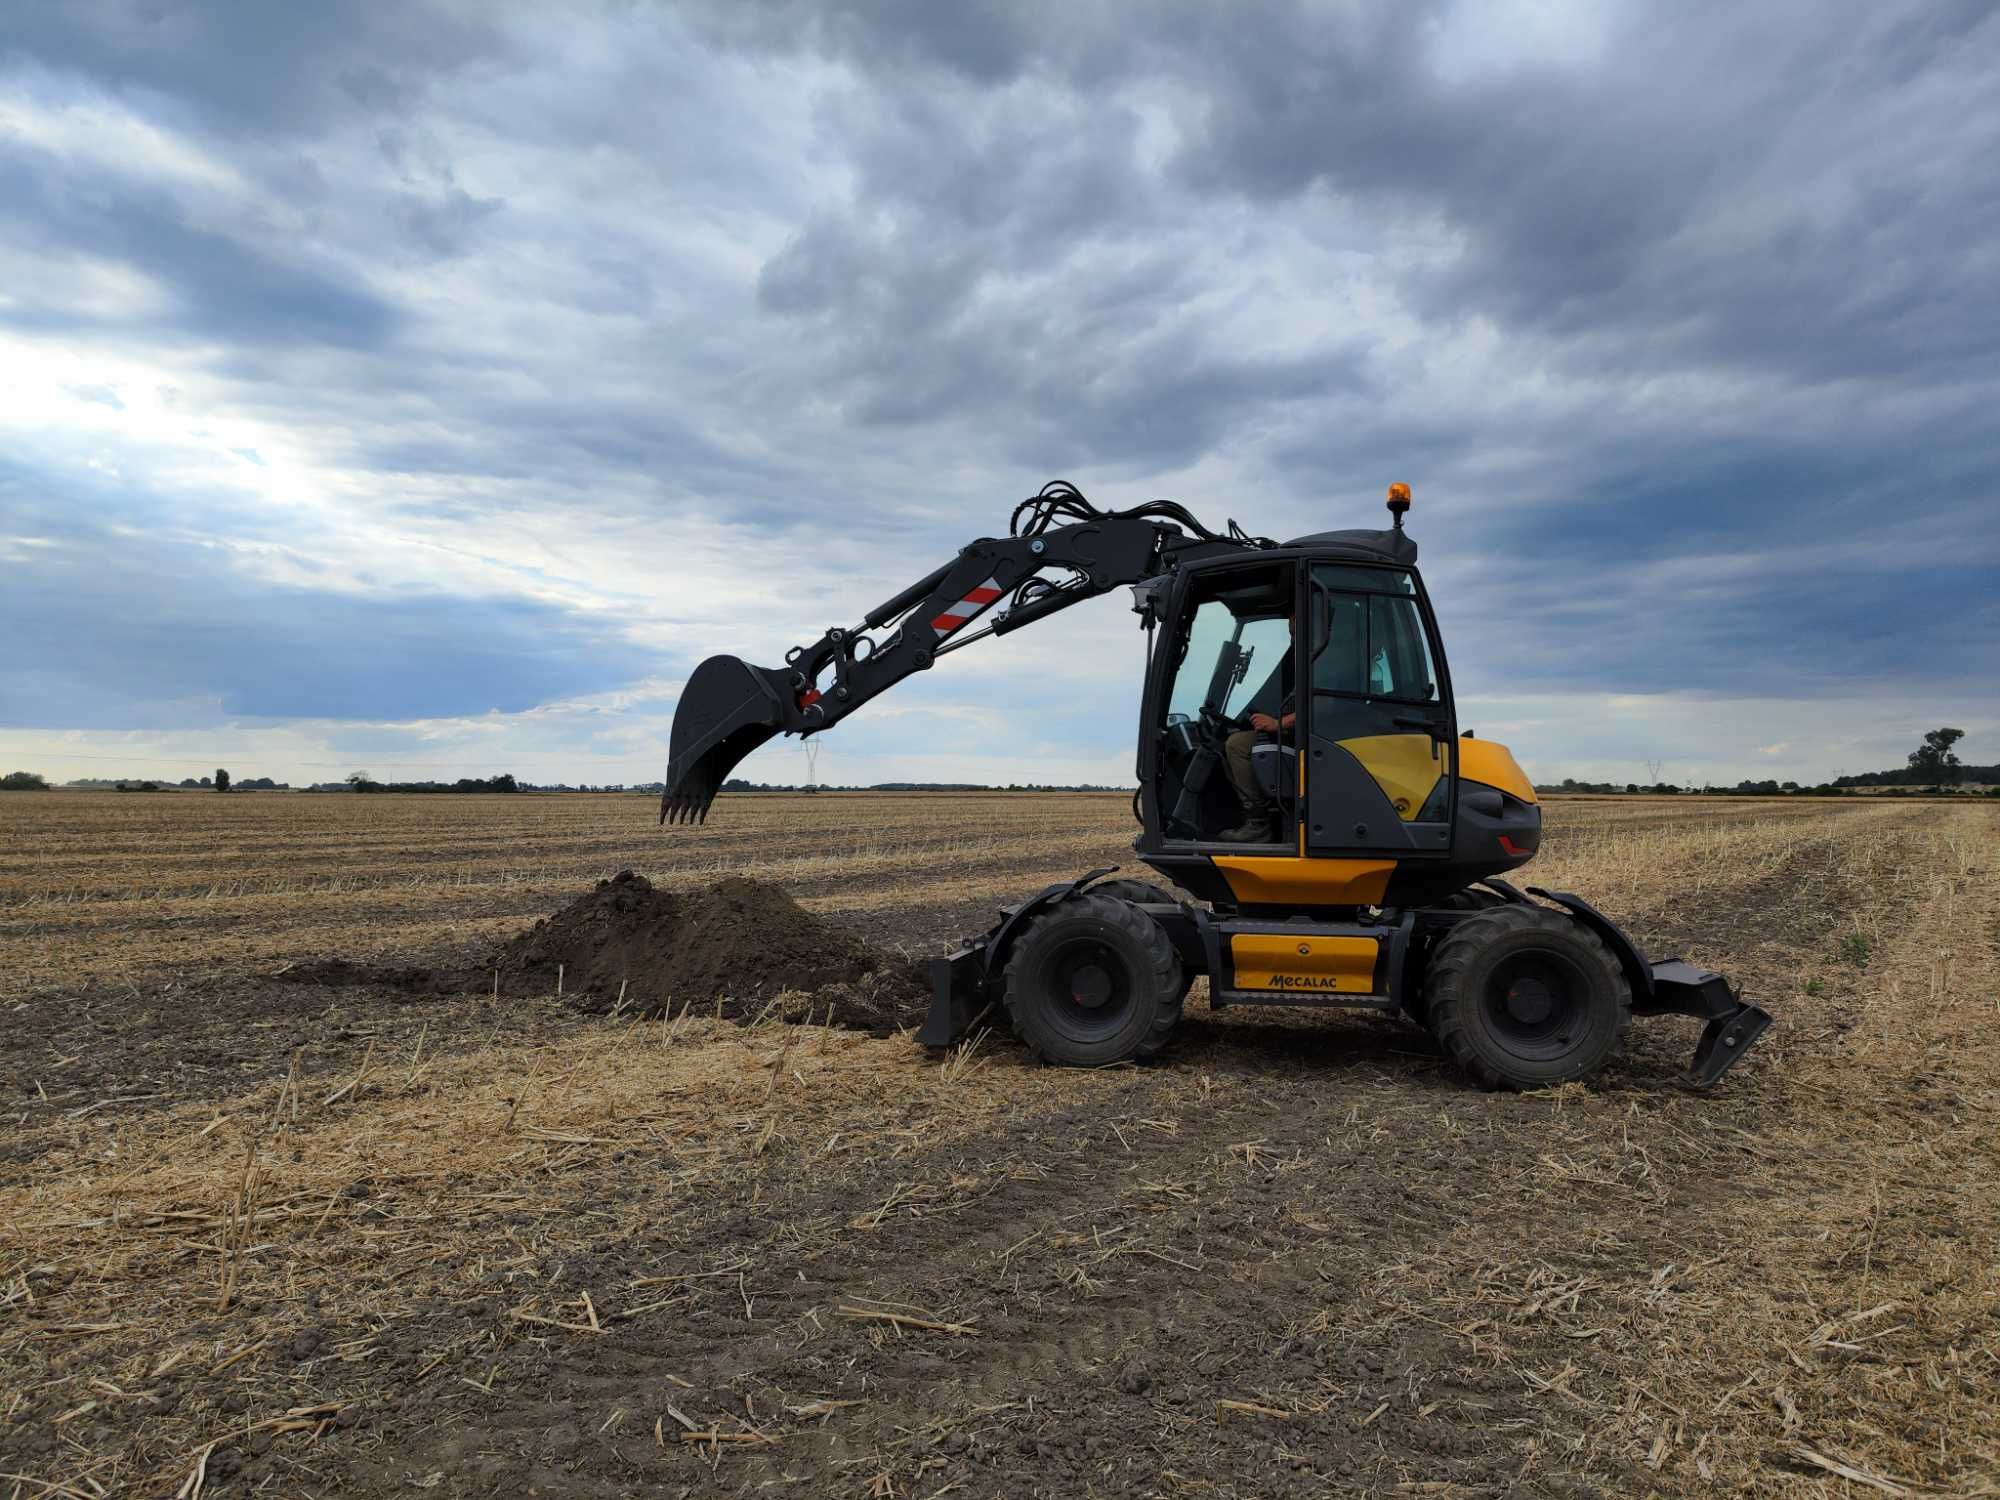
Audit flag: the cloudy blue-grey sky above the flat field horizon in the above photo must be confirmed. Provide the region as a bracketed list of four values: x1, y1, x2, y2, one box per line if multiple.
[0, 0, 2000, 782]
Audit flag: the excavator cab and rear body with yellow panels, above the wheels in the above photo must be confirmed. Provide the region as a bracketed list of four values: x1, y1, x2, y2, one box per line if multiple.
[1134, 524, 1542, 910]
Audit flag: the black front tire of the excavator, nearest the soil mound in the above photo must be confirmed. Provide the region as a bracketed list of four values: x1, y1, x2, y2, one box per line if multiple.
[1002, 882, 1184, 1068]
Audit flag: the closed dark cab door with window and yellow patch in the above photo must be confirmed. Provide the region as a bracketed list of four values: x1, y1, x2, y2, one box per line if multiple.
[1298, 562, 1458, 858]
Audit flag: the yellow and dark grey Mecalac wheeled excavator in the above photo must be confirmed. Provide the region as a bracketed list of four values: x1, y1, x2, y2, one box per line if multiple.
[660, 482, 1770, 1088]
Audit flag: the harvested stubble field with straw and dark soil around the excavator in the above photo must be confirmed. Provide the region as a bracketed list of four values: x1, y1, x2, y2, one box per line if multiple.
[0, 794, 2000, 1500]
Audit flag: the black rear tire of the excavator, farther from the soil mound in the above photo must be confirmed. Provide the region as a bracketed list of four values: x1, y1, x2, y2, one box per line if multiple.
[1424, 902, 1632, 1088]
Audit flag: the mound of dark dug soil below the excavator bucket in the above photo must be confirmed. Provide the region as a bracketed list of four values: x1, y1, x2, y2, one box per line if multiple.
[494, 870, 928, 1026]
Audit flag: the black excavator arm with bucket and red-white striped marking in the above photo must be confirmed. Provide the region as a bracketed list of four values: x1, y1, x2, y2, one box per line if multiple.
[660, 482, 1270, 822]
